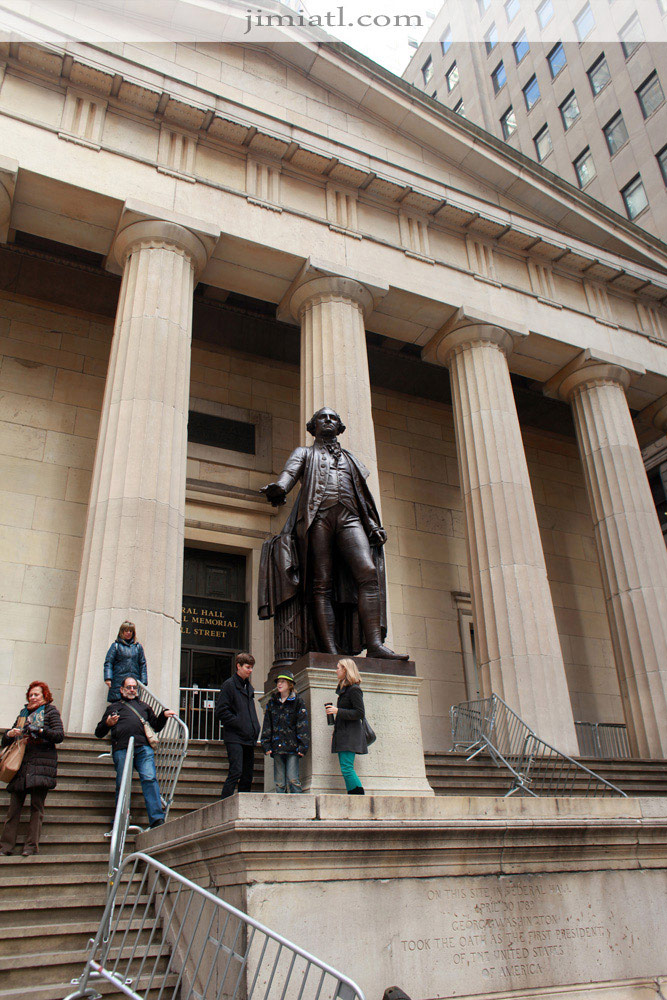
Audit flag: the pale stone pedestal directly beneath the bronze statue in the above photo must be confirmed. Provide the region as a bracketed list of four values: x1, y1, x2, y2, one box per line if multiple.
[262, 653, 433, 797]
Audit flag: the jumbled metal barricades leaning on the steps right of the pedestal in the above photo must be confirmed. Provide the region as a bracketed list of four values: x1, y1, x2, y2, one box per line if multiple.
[450, 694, 627, 798]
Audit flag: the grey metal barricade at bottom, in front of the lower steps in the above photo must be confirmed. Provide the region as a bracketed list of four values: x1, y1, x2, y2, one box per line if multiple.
[65, 852, 365, 1000]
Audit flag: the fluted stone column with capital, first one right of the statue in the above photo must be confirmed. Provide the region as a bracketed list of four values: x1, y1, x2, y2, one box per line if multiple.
[425, 315, 578, 753]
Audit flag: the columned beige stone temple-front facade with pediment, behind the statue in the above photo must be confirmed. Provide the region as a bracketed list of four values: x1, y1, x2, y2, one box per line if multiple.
[0, 0, 667, 756]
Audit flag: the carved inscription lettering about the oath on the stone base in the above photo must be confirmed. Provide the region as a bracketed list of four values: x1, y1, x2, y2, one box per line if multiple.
[398, 878, 611, 983]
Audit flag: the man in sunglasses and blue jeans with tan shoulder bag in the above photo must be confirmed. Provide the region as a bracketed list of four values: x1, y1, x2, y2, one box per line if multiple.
[95, 676, 176, 828]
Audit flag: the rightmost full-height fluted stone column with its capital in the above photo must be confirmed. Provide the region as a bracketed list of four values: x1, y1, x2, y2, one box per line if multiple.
[546, 351, 667, 757]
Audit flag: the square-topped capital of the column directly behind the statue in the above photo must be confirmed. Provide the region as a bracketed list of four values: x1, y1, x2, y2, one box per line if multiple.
[276, 257, 389, 323]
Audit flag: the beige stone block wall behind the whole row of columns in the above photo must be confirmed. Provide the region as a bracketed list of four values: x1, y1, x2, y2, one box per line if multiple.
[0, 295, 622, 750]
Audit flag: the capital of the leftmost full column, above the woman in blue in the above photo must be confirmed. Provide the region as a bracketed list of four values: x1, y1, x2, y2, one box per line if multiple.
[107, 200, 220, 276]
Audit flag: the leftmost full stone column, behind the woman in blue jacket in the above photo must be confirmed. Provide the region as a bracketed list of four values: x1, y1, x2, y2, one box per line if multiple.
[65, 207, 214, 732]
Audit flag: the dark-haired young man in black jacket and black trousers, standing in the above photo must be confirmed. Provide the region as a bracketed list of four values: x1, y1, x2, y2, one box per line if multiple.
[215, 653, 259, 799]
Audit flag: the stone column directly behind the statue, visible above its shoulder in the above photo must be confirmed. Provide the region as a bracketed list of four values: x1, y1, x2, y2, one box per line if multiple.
[279, 261, 388, 509]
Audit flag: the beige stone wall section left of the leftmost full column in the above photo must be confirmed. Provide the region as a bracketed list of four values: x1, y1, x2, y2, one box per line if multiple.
[0, 293, 111, 712]
